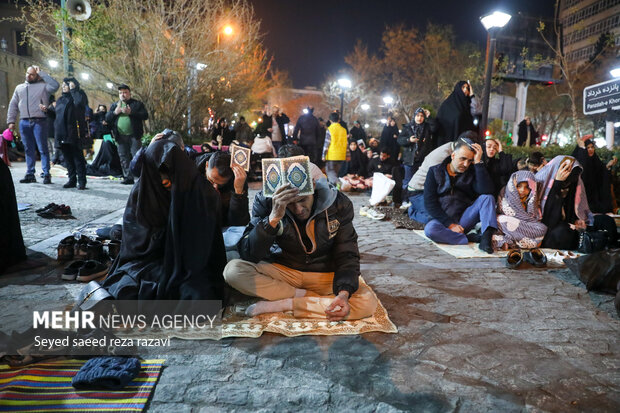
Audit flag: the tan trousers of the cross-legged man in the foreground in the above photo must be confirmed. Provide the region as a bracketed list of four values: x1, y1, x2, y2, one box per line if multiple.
[224, 259, 377, 320]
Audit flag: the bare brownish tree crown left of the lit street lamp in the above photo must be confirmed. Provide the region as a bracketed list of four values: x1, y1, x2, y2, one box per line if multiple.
[345, 23, 484, 121]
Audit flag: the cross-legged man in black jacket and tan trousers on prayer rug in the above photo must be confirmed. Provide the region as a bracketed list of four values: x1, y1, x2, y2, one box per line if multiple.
[224, 179, 377, 321]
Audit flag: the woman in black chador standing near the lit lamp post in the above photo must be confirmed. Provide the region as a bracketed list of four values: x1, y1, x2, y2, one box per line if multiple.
[436, 81, 477, 147]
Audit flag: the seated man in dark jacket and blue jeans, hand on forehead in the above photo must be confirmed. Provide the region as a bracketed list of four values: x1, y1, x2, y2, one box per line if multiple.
[424, 138, 497, 254]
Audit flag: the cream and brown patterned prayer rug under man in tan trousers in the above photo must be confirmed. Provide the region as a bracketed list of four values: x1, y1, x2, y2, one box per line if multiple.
[118, 280, 398, 340]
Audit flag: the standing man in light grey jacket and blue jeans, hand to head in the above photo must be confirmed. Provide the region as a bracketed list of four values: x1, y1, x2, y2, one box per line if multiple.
[6, 66, 60, 184]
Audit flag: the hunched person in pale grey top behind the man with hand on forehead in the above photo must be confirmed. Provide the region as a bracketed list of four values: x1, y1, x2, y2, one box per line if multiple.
[407, 131, 478, 224]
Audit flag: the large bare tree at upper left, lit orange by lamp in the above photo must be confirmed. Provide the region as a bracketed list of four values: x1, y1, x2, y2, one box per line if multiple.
[7, 0, 270, 130]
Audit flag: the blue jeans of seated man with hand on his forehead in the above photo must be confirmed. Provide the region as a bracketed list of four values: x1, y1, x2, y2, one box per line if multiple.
[424, 195, 497, 245]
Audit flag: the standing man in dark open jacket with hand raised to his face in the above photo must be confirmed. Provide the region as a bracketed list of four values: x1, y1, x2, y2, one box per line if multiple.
[105, 84, 149, 185]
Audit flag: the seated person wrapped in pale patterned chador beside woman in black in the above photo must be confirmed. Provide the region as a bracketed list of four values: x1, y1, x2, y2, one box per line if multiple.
[493, 171, 547, 249]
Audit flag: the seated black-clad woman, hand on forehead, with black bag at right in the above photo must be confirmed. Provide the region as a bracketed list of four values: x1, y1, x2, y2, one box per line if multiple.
[536, 156, 617, 250]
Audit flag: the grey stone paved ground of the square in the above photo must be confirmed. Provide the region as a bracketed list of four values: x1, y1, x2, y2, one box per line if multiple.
[0, 160, 620, 413]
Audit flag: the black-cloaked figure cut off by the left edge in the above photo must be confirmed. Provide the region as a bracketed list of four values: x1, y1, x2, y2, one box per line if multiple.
[0, 159, 26, 274]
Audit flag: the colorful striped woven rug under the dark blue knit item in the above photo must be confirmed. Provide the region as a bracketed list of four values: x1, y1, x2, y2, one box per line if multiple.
[0, 360, 164, 412]
